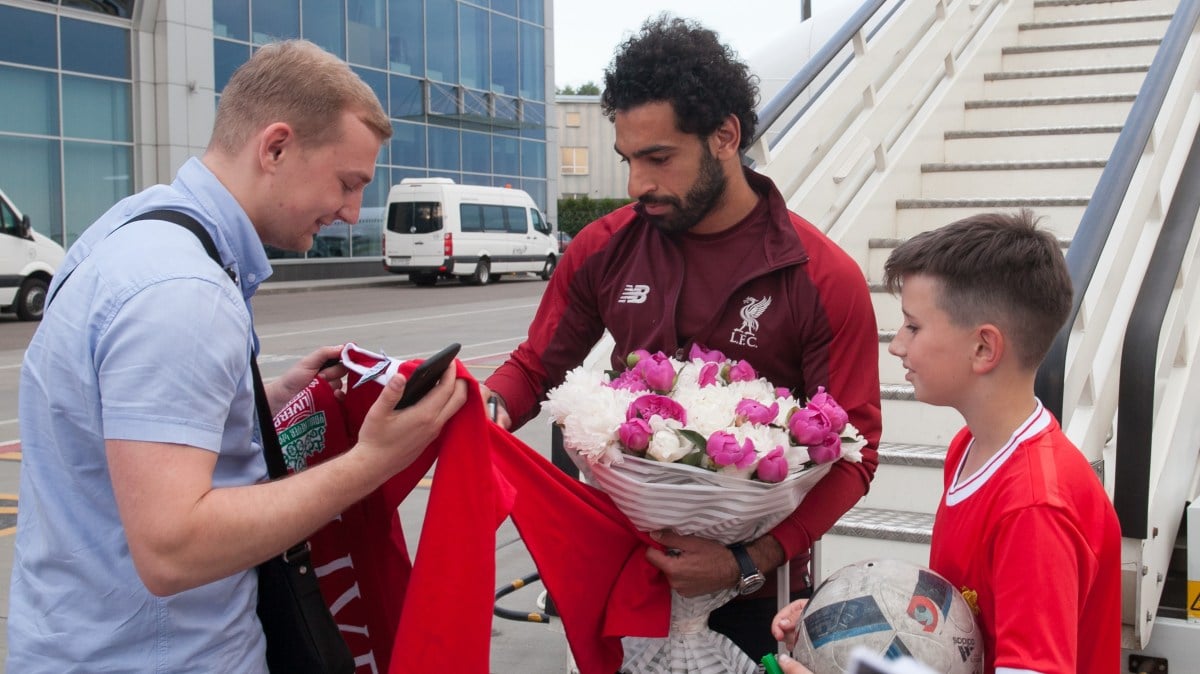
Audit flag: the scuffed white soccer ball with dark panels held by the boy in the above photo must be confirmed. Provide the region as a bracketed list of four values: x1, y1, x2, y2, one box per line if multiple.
[792, 559, 983, 674]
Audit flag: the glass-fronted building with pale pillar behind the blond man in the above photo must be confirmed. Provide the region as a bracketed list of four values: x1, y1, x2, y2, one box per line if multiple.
[0, 0, 557, 273]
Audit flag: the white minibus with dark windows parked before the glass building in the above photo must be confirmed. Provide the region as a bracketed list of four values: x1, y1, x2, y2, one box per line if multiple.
[383, 177, 558, 285]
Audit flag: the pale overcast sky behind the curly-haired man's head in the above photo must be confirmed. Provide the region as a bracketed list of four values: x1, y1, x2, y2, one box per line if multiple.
[554, 0, 800, 88]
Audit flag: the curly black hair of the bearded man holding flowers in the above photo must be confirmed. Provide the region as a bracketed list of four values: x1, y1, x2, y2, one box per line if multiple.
[600, 13, 758, 150]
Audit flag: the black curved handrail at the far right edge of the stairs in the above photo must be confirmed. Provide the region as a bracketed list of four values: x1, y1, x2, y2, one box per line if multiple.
[1112, 124, 1200, 538]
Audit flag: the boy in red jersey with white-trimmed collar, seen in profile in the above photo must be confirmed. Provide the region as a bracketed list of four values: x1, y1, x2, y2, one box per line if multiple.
[884, 210, 1121, 674]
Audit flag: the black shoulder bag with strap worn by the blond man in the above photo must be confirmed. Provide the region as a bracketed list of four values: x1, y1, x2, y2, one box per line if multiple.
[47, 210, 354, 674]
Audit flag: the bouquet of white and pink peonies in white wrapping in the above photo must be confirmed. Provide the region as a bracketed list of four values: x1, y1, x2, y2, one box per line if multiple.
[544, 347, 865, 674]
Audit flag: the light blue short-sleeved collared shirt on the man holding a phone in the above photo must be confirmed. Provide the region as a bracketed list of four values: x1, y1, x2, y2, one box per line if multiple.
[7, 158, 271, 674]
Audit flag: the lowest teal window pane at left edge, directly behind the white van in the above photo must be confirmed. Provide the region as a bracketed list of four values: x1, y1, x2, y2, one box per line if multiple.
[0, 136, 61, 243]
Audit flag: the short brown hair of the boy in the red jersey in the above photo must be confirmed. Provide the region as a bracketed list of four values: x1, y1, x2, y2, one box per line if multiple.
[883, 209, 1072, 369]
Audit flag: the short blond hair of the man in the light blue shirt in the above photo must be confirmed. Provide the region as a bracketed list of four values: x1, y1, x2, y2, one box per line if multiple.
[209, 40, 391, 155]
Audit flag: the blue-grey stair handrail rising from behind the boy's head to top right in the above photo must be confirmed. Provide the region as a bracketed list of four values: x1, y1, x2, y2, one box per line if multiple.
[1034, 0, 1200, 419]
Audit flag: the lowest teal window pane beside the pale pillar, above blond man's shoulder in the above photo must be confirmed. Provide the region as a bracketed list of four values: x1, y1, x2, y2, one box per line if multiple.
[62, 140, 133, 245]
